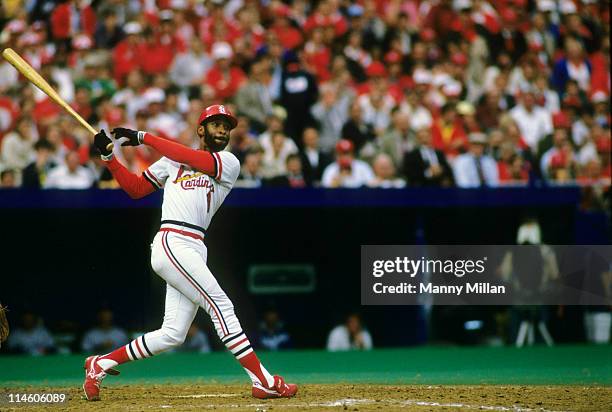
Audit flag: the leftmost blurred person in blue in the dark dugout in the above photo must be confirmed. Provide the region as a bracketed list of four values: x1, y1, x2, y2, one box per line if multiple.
[7, 311, 55, 356]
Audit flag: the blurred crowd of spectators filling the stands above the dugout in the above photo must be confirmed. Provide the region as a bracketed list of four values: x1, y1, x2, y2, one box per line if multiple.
[0, 0, 610, 191]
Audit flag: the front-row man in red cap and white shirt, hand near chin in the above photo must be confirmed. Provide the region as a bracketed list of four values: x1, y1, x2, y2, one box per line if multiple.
[321, 139, 375, 188]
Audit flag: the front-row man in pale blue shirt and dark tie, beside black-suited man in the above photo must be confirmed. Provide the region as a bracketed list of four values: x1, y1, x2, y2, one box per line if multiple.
[453, 133, 499, 188]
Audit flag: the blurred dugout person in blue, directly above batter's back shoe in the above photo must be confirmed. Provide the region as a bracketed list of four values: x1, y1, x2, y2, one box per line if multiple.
[81, 309, 128, 353]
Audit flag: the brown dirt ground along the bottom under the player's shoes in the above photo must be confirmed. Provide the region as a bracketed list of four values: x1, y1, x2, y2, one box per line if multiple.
[0, 384, 612, 412]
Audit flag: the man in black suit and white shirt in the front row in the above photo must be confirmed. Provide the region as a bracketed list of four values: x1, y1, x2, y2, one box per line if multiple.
[403, 127, 454, 187]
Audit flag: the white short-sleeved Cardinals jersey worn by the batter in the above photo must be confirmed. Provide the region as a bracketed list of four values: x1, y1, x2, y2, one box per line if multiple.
[144, 151, 240, 235]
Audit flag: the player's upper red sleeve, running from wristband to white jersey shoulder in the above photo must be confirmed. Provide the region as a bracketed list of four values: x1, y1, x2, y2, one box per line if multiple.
[142, 133, 218, 177]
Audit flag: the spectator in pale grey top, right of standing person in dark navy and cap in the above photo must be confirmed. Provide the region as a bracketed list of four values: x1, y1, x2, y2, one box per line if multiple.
[310, 82, 353, 153]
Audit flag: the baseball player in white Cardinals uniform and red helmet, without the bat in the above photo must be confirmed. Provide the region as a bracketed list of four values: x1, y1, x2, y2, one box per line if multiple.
[83, 105, 297, 400]
